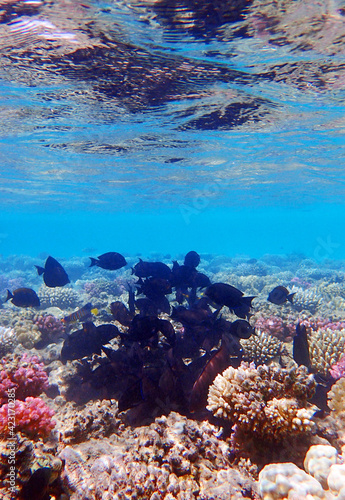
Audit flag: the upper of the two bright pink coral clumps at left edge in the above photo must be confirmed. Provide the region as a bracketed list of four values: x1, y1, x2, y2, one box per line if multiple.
[0, 353, 48, 403]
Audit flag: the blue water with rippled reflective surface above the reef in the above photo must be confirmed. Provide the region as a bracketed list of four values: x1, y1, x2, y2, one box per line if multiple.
[0, 1, 345, 261]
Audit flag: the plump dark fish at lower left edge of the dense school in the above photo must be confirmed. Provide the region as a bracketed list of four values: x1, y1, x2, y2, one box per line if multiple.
[61, 322, 120, 363]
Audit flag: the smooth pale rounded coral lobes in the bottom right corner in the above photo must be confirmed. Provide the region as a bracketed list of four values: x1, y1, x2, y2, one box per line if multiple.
[259, 445, 345, 500]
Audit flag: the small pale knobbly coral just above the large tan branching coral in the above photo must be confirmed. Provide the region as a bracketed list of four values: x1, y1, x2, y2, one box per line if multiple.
[241, 330, 283, 365]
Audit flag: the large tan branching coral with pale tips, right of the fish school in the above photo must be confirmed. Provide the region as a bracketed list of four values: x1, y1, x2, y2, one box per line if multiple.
[207, 362, 315, 441]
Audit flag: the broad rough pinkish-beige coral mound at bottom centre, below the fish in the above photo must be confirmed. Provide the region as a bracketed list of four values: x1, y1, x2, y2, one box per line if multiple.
[60, 413, 257, 500]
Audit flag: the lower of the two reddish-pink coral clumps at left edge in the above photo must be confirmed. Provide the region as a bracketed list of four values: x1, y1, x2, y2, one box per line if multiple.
[0, 396, 55, 437]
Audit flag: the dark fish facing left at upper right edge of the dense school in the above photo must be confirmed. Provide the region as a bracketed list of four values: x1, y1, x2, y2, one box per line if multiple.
[205, 283, 255, 319]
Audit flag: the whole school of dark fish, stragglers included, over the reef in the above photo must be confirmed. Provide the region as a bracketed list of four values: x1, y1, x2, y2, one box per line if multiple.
[6, 251, 314, 418]
